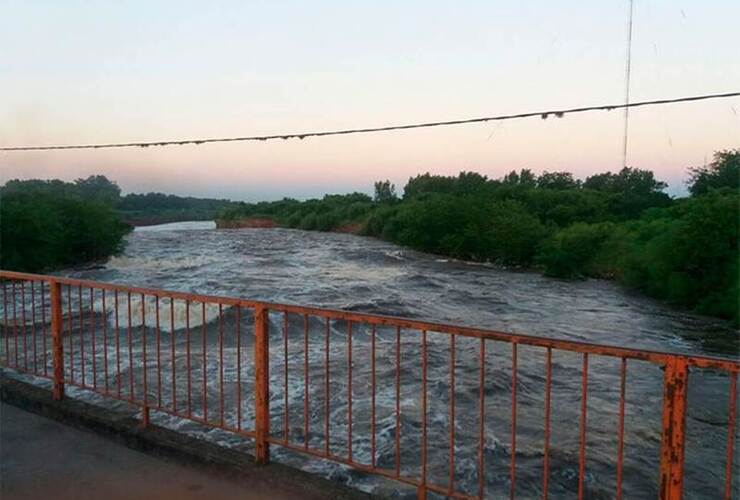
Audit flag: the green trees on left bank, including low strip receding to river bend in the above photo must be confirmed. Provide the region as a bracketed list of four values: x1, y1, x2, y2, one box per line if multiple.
[0, 175, 232, 272]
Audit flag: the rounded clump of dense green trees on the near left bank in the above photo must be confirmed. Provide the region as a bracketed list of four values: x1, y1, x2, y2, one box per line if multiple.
[0, 176, 130, 272]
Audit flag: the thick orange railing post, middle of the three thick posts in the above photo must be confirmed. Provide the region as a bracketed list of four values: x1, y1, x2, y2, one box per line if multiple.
[254, 306, 270, 465]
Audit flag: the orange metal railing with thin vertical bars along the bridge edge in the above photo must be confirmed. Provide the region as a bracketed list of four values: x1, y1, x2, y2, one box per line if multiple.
[0, 271, 740, 499]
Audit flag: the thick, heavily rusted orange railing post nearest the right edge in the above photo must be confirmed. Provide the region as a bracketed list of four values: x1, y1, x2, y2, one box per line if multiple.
[659, 356, 689, 500]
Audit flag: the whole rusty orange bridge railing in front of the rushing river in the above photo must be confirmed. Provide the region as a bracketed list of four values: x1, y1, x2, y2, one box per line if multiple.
[0, 271, 740, 499]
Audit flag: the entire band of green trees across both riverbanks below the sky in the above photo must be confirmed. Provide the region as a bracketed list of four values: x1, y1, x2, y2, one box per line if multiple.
[0, 149, 740, 323]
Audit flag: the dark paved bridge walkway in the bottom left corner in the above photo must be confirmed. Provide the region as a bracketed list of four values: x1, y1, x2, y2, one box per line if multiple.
[0, 403, 305, 500]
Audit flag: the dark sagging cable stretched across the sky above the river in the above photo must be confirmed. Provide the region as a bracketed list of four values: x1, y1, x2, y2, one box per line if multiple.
[0, 92, 740, 151]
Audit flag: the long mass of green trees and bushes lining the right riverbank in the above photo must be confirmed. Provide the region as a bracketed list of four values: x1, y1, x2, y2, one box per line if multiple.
[219, 150, 740, 322]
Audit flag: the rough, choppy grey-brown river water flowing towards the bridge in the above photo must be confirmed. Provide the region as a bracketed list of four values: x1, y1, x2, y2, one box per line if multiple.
[17, 223, 740, 498]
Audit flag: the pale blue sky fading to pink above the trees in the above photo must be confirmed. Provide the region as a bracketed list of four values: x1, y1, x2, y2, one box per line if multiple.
[0, 0, 740, 201]
